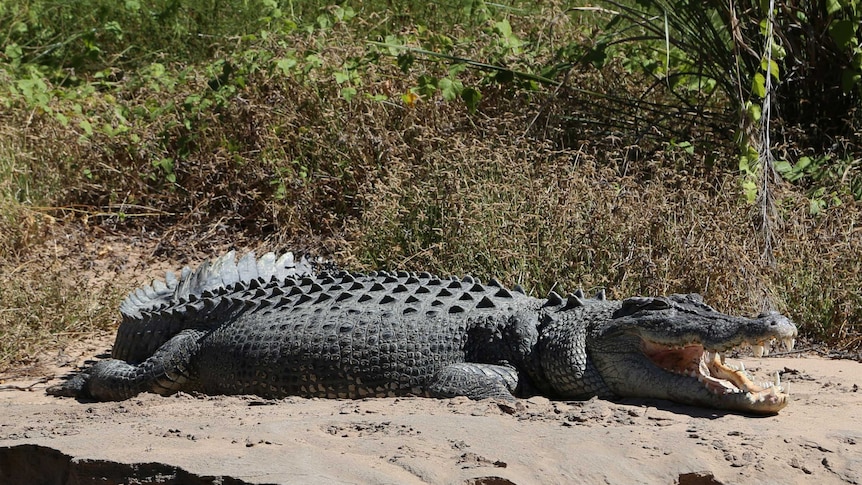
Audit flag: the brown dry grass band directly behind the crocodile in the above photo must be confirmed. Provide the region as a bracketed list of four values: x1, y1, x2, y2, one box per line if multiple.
[0, 15, 862, 369]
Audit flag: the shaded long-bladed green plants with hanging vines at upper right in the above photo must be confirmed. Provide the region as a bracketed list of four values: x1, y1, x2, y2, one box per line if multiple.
[571, 0, 862, 197]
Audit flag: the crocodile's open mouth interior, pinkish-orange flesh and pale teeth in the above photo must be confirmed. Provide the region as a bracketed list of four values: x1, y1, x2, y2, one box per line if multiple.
[642, 339, 794, 402]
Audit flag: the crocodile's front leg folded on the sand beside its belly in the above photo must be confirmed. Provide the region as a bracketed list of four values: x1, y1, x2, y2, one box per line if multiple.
[427, 362, 518, 400]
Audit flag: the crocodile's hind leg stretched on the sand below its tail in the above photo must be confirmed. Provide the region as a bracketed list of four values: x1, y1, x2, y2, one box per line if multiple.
[48, 330, 204, 401]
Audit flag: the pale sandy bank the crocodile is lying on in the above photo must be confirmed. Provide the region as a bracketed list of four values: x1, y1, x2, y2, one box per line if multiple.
[0, 339, 862, 485]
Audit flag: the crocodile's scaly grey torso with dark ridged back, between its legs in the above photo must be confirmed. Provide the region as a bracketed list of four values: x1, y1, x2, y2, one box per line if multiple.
[187, 271, 541, 398]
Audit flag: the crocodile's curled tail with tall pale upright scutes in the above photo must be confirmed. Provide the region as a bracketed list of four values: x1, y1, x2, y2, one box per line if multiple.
[112, 251, 319, 362]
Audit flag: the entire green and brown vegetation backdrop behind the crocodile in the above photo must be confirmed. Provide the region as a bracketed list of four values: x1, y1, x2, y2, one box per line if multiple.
[0, 0, 862, 369]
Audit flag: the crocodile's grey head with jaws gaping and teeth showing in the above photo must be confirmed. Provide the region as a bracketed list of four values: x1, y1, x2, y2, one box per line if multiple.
[586, 294, 797, 414]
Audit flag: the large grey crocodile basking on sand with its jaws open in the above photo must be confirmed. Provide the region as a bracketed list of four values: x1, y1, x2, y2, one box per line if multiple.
[48, 251, 797, 414]
